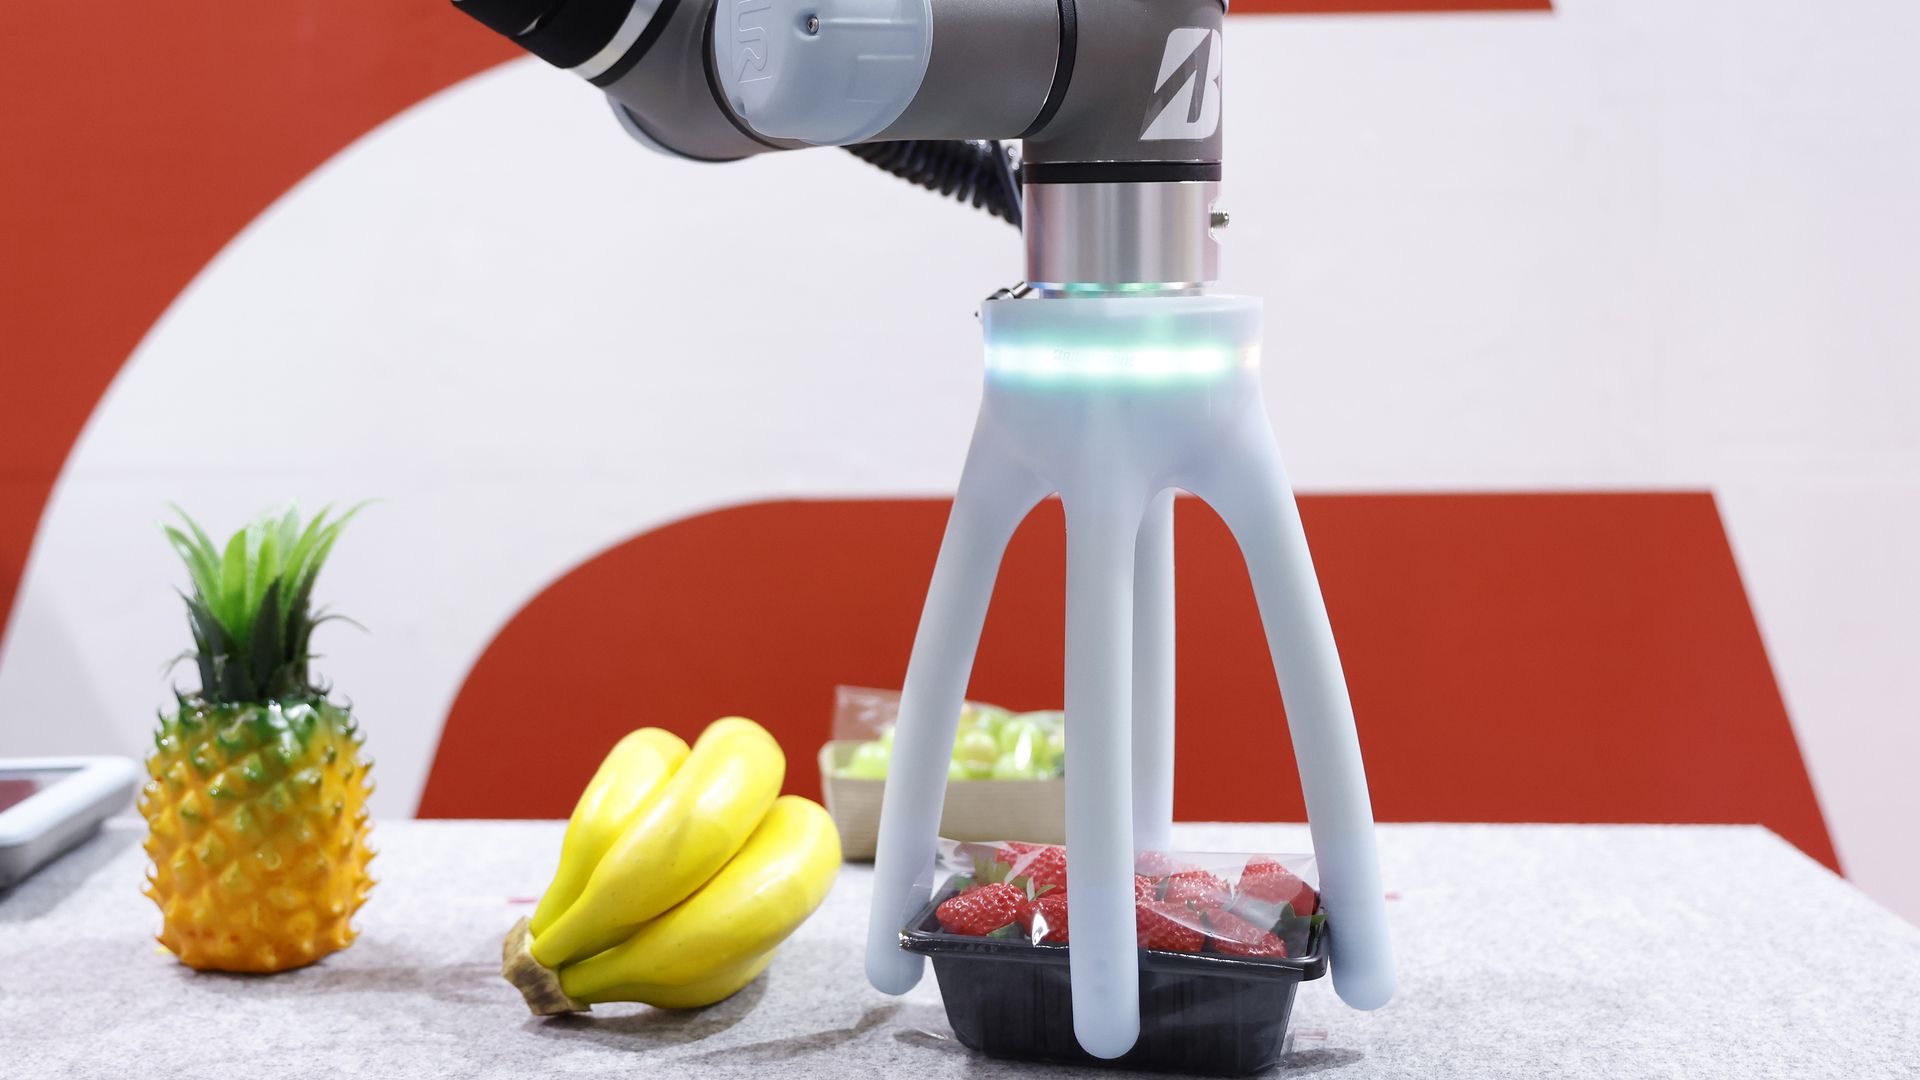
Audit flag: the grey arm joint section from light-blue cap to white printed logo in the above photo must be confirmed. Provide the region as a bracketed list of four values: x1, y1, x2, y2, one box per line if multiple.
[714, 0, 1223, 163]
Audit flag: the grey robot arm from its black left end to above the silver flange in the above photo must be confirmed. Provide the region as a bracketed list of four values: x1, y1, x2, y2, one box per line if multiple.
[455, 0, 1223, 163]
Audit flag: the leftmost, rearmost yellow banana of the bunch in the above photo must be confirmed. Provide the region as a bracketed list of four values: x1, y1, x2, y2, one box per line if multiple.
[530, 728, 687, 936]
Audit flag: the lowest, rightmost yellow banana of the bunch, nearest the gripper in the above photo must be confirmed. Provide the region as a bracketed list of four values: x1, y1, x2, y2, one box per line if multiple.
[561, 796, 841, 1001]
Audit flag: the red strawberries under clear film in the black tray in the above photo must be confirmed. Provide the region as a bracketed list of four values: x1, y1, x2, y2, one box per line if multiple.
[933, 840, 1327, 959]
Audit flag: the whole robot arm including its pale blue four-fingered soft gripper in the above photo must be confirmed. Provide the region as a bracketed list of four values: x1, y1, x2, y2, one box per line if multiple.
[455, 0, 1394, 1057]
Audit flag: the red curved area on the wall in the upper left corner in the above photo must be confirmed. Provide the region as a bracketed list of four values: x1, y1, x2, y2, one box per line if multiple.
[0, 0, 515, 630]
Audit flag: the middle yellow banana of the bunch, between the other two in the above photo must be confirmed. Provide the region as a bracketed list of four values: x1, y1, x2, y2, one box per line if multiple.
[532, 717, 787, 969]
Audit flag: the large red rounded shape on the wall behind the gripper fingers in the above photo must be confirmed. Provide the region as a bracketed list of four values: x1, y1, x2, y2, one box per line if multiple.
[420, 494, 1837, 867]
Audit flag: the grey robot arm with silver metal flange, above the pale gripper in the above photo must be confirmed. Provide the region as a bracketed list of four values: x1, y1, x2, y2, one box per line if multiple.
[455, 0, 1223, 290]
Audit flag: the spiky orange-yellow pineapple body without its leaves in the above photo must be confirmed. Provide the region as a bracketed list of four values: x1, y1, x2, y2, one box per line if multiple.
[140, 700, 372, 972]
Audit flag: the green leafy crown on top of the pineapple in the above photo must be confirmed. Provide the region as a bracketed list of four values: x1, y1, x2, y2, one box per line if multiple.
[161, 503, 367, 701]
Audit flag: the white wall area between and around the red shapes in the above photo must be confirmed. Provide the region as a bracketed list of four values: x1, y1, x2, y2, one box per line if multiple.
[0, 0, 1920, 920]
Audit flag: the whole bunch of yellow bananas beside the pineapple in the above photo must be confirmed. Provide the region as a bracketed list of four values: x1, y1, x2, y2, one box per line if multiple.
[501, 717, 841, 1015]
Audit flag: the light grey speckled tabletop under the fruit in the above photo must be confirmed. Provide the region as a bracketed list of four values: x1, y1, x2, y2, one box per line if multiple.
[0, 821, 1920, 1080]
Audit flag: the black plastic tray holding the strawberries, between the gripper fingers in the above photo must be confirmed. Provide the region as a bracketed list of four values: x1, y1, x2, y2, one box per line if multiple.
[900, 888, 1327, 1076]
